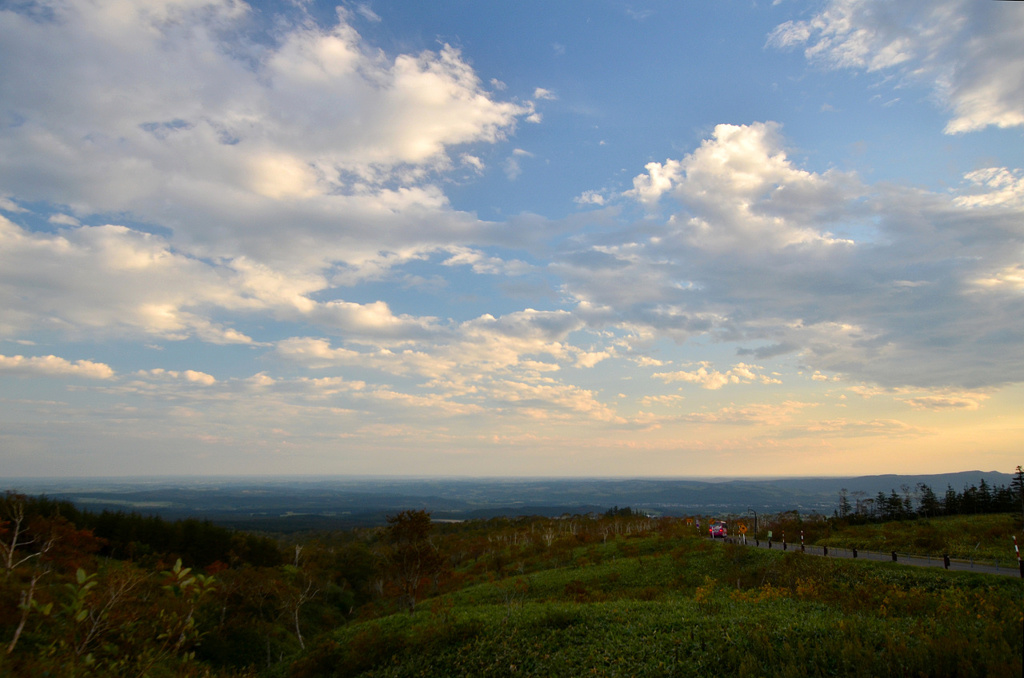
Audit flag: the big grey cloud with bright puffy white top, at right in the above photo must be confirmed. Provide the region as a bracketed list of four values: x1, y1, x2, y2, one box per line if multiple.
[552, 123, 1024, 388]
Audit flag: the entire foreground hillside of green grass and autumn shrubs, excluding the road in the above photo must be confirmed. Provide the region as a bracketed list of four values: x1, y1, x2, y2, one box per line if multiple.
[0, 493, 1024, 678]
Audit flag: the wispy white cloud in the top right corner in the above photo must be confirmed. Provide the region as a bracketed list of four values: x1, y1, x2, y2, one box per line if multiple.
[768, 0, 1024, 134]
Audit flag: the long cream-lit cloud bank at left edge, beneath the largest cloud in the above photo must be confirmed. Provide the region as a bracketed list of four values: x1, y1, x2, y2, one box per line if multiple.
[0, 216, 481, 344]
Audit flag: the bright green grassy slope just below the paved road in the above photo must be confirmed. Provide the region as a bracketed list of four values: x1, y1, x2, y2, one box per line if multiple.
[292, 537, 1024, 677]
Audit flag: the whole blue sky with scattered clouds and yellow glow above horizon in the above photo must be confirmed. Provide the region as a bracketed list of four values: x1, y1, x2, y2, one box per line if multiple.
[0, 0, 1024, 476]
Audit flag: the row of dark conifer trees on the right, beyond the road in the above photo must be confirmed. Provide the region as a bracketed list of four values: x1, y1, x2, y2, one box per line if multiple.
[836, 466, 1024, 522]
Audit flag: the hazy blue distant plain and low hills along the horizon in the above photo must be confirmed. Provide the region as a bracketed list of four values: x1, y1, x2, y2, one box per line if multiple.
[6, 471, 1012, 532]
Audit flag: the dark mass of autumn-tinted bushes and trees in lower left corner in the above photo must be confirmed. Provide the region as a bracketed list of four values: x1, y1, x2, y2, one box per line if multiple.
[0, 493, 375, 676]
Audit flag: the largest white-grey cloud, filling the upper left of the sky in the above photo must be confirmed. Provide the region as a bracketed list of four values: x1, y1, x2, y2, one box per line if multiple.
[0, 0, 532, 276]
